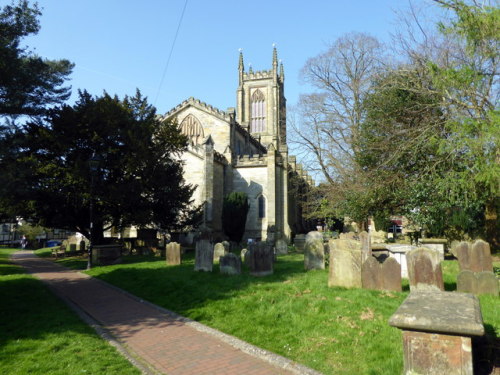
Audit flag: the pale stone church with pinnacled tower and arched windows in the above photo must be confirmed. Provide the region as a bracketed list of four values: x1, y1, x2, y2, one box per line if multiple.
[163, 48, 313, 241]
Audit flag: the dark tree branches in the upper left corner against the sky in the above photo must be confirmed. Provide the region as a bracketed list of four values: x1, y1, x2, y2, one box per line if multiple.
[0, 0, 73, 118]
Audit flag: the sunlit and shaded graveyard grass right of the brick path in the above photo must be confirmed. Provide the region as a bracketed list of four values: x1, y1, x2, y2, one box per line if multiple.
[47, 248, 500, 374]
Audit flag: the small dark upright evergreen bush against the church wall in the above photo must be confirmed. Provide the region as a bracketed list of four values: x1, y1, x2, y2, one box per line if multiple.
[222, 191, 250, 243]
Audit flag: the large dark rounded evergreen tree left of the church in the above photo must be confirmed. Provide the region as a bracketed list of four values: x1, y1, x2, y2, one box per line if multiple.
[0, 92, 199, 243]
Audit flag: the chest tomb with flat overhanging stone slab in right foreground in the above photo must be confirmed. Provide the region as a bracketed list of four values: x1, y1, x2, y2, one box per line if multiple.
[389, 291, 484, 375]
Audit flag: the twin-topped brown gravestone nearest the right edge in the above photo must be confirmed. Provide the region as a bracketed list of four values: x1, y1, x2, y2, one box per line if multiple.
[456, 240, 493, 272]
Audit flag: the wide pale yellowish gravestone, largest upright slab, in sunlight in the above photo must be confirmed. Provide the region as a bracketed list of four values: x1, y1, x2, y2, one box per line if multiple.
[328, 238, 362, 288]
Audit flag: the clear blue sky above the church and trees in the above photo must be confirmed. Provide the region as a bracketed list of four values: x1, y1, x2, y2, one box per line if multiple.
[16, 0, 438, 113]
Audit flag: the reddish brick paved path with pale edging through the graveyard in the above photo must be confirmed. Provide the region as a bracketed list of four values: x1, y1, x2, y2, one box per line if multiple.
[13, 251, 319, 375]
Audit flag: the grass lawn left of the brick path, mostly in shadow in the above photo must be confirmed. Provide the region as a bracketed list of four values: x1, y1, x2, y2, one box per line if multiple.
[0, 249, 140, 375]
